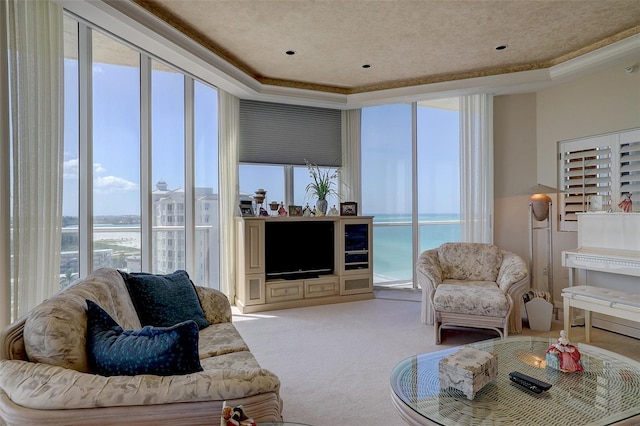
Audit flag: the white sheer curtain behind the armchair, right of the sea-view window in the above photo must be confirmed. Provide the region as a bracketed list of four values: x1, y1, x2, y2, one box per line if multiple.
[460, 94, 493, 243]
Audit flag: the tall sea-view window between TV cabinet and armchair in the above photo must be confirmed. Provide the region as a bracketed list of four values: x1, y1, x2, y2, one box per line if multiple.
[362, 99, 460, 286]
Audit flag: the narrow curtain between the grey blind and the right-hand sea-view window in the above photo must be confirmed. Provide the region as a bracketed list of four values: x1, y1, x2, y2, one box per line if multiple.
[340, 109, 362, 206]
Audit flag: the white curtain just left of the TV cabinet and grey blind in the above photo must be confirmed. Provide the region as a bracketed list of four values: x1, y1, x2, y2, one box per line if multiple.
[218, 89, 240, 298]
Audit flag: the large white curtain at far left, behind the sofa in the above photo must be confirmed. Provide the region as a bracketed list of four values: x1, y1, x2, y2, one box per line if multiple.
[7, 0, 64, 318]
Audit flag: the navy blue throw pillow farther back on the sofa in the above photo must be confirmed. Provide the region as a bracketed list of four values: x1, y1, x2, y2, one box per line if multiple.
[120, 270, 209, 330]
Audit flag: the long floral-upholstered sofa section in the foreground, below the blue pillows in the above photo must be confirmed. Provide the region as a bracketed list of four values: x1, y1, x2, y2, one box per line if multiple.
[0, 360, 280, 410]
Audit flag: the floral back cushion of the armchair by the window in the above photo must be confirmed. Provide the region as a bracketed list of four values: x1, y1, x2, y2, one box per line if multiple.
[438, 243, 502, 282]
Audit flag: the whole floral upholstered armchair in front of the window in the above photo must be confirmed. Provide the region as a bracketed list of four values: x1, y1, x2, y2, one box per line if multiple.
[416, 243, 529, 344]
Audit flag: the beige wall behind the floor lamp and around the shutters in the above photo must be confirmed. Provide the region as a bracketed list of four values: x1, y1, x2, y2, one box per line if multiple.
[494, 61, 640, 312]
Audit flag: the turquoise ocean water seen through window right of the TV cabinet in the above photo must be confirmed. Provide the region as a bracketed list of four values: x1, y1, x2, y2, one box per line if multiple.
[373, 214, 460, 284]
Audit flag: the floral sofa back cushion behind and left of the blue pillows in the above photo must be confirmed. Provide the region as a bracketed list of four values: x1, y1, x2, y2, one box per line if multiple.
[24, 268, 142, 372]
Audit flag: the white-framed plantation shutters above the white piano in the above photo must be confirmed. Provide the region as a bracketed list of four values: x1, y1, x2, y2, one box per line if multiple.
[558, 129, 640, 231]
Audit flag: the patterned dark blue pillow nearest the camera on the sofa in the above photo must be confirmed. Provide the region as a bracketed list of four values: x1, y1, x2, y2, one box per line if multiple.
[87, 299, 202, 376]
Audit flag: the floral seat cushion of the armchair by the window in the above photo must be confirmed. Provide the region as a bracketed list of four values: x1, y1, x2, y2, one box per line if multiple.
[433, 280, 509, 318]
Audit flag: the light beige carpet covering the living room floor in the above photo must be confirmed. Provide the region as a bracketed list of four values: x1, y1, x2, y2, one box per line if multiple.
[234, 292, 640, 426]
